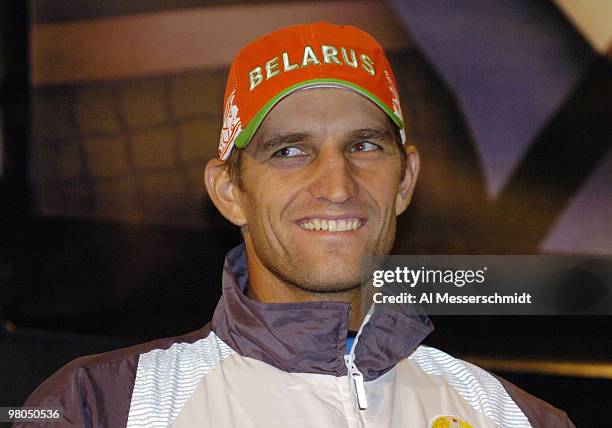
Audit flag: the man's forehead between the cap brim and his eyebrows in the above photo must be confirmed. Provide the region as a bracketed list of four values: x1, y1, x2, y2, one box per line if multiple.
[249, 88, 393, 146]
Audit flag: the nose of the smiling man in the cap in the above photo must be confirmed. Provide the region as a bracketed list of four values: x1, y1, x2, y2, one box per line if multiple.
[310, 149, 359, 204]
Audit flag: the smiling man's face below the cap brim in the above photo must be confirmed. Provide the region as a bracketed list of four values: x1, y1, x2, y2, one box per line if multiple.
[236, 88, 412, 292]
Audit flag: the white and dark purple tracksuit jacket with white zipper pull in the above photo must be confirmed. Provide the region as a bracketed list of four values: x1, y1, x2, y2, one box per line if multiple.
[15, 245, 573, 428]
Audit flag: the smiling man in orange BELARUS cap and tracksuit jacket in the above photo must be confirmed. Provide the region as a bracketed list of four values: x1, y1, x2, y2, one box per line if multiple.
[19, 23, 573, 427]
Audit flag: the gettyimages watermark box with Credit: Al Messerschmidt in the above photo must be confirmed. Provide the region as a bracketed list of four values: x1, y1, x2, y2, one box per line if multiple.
[370, 255, 612, 315]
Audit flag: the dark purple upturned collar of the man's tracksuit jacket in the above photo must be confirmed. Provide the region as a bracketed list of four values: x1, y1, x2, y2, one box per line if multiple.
[212, 244, 433, 380]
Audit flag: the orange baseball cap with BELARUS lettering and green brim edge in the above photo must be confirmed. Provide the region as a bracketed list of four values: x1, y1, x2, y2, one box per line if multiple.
[219, 22, 405, 160]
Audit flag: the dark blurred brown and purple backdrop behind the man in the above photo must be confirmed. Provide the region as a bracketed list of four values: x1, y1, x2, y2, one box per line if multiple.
[0, 0, 612, 427]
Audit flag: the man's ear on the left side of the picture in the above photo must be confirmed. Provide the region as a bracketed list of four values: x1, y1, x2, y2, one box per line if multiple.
[204, 159, 246, 226]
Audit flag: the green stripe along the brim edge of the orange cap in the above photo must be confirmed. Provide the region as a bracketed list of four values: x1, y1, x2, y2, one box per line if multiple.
[234, 79, 404, 149]
